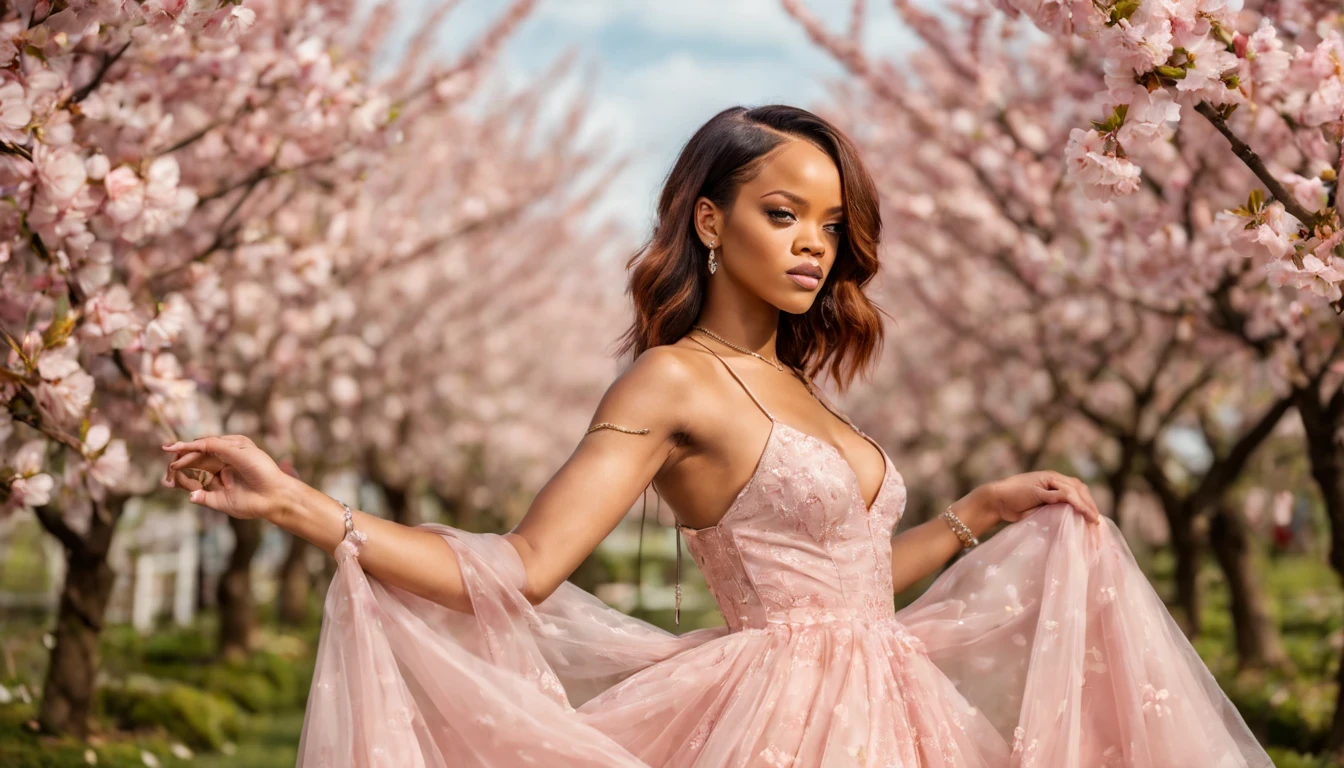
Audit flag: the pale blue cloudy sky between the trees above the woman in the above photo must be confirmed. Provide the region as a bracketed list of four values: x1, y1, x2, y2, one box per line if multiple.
[384, 0, 913, 238]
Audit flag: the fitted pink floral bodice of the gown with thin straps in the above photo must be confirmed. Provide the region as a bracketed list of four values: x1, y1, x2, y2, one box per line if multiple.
[677, 338, 906, 631]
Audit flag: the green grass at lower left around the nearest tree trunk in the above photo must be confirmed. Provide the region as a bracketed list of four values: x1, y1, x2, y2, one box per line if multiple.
[0, 611, 319, 768]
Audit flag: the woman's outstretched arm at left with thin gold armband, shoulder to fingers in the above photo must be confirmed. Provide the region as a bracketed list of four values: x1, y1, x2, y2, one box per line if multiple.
[165, 347, 692, 612]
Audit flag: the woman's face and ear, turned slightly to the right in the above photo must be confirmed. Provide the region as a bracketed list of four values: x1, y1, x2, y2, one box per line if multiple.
[696, 140, 844, 315]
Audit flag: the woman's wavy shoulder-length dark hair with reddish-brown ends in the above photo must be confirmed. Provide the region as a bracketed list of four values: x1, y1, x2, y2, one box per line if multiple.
[617, 104, 890, 390]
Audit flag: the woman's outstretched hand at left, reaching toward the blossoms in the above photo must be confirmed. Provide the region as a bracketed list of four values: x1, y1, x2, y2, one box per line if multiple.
[160, 434, 296, 519]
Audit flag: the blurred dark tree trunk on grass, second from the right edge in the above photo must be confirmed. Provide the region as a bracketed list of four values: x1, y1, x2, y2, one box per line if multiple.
[1208, 504, 1288, 670]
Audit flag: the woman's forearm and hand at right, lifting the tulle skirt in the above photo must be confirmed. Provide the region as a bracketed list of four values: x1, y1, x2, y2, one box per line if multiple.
[891, 471, 1101, 593]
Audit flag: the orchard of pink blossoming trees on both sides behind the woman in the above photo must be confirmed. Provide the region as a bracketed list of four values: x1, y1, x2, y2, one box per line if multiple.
[0, 0, 1344, 765]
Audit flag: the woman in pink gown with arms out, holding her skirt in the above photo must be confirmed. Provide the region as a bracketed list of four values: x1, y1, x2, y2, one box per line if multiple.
[164, 106, 1270, 768]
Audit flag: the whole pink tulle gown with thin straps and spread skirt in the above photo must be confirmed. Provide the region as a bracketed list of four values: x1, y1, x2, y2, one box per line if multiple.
[298, 350, 1271, 768]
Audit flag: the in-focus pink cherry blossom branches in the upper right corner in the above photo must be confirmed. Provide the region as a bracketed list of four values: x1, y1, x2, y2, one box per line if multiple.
[995, 0, 1344, 312]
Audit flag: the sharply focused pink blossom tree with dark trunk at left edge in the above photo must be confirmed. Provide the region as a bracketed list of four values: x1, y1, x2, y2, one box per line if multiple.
[0, 3, 267, 733]
